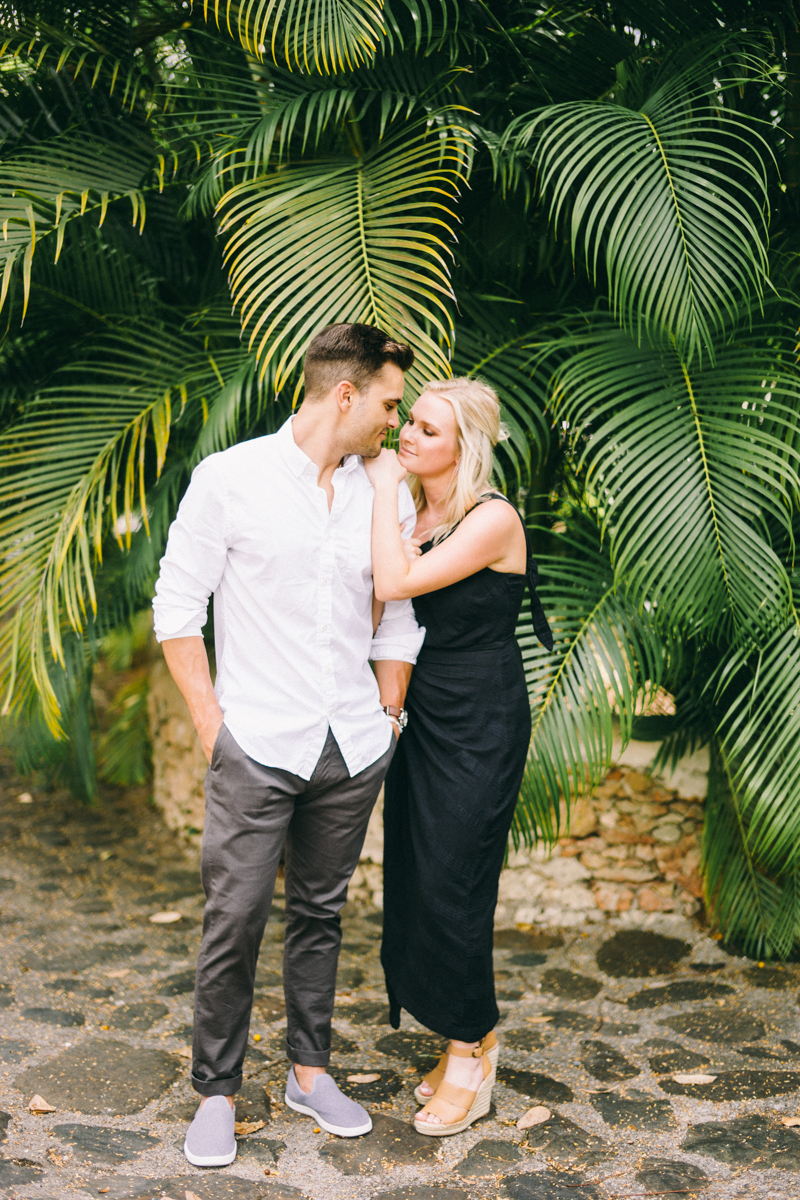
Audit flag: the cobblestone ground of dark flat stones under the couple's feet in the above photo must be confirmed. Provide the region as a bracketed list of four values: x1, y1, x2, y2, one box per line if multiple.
[0, 748, 800, 1200]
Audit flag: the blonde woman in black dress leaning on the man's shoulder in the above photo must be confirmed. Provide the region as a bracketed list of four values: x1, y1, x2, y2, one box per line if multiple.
[365, 379, 552, 1136]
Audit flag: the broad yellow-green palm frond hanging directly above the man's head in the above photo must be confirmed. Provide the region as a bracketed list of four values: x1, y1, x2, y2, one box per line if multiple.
[219, 116, 469, 388]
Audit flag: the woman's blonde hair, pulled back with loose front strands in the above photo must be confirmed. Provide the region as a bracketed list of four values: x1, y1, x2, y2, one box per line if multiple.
[408, 378, 509, 542]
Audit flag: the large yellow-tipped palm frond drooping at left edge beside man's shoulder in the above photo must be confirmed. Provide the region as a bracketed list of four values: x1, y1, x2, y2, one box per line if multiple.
[0, 322, 241, 733]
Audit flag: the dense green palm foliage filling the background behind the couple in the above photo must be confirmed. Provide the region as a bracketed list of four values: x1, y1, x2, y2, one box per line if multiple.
[0, 0, 800, 956]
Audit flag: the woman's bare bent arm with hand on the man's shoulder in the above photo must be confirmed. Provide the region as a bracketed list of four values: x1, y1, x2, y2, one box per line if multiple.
[365, 450, 525, 600]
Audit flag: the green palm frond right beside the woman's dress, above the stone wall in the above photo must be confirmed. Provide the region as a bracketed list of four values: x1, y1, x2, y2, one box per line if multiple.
[512, 526, 675, 846]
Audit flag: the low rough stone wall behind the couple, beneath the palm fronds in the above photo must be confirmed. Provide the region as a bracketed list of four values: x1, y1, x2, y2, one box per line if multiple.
[149, 661, 708, 926]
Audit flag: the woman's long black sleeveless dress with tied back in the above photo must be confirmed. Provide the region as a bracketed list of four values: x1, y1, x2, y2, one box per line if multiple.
[381, 497, 553, 1042]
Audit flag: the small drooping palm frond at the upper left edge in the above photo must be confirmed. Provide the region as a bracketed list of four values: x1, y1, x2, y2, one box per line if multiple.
[0, 134, 151, 317]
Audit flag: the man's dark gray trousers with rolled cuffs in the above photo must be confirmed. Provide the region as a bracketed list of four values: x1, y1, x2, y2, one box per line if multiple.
[192, 725, 395, 1096]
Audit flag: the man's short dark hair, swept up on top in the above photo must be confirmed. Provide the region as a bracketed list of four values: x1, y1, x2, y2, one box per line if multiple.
[305, 325, 414, 400]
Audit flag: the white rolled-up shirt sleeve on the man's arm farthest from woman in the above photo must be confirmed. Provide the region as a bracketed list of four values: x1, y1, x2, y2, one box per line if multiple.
[152, 455, 228, 642]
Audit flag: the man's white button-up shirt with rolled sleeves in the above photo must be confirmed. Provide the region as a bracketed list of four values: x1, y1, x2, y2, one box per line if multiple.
[152, 419, 425, 779]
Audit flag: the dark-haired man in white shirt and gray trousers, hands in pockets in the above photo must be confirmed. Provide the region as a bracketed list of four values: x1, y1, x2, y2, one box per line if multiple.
[154, 325, 425, 1166]
